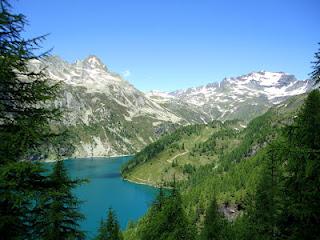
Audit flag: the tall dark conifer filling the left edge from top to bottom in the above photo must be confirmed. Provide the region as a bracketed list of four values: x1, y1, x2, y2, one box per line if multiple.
[0, 0, 67, 239]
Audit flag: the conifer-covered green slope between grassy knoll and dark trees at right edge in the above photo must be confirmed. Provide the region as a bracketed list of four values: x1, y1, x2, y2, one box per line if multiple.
[124, 95, 306, 240]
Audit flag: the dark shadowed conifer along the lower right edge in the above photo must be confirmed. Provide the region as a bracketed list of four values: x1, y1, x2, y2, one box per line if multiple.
[281, 90, 320, 239]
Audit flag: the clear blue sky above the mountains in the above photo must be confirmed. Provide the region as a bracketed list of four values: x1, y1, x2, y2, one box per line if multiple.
[11, 0, 320, 91]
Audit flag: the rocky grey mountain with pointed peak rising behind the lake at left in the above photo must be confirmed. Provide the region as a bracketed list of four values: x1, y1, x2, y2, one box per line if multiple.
[31, 56, 205, 157]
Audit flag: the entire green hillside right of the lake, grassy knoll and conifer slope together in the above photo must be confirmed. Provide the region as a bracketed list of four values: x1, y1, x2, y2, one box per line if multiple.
[123, 95, 306, 239]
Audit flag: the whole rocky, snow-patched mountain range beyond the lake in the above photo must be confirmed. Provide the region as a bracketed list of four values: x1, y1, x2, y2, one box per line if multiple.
[31, 56, 313, 157]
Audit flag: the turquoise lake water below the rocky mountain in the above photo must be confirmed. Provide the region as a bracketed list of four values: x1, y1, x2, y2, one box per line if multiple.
[45, 157, 158, 239]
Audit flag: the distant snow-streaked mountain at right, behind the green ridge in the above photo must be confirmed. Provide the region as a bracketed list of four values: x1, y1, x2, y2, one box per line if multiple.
[148, 71, 313, 121]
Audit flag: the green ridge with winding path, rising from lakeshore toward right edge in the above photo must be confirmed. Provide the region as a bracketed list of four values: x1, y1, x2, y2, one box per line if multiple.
[122, 95, 305, 185]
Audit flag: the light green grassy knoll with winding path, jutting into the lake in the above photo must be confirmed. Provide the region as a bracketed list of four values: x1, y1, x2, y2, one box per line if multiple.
[123, 121, 241, 185]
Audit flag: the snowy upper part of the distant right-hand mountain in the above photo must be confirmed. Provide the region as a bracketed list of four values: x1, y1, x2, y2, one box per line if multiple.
[168, 71, 311, 106]
